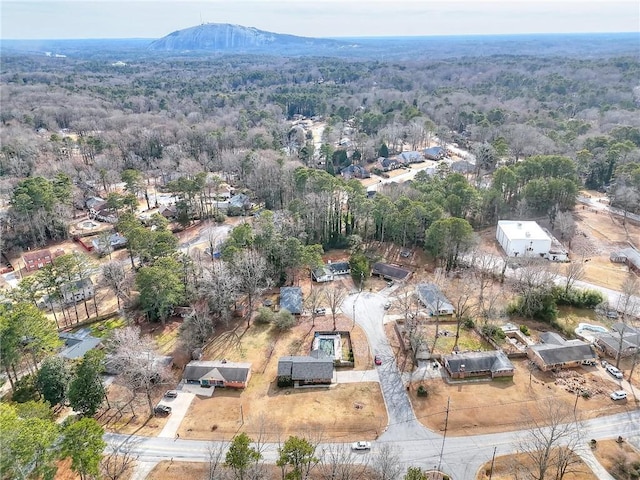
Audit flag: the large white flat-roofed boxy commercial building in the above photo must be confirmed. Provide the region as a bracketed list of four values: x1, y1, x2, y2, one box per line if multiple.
[496, 220, 551, 258]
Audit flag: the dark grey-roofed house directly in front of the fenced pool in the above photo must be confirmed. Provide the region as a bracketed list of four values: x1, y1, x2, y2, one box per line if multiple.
[278, 350, 333, 387]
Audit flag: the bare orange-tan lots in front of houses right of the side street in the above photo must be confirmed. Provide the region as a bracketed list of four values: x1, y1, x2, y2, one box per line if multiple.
[410, 359, 635, 436]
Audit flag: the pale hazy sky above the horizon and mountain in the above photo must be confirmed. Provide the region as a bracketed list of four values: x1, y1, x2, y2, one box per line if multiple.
[0, 0, 640, 39]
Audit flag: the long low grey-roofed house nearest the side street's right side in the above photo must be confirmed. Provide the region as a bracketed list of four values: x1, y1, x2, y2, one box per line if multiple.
[443, 350, 515, 378]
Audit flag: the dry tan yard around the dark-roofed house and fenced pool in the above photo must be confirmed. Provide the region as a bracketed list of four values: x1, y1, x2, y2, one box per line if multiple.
[172, 312, 387, 441]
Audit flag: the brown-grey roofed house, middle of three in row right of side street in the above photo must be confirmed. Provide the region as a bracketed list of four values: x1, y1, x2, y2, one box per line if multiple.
[526, 332, 597, 372]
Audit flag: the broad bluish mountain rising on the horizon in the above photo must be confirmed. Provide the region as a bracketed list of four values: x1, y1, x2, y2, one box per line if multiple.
[149, 23, 348, 53]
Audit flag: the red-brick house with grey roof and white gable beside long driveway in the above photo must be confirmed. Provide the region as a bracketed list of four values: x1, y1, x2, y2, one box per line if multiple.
[182, 360, 251, 388]
